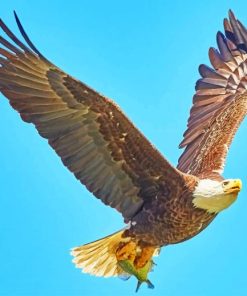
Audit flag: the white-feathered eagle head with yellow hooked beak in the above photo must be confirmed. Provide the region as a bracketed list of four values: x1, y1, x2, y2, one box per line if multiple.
[192, 179, 242, 213]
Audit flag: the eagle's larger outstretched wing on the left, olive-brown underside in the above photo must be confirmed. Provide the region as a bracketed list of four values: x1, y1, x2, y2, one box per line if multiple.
[0, 16, 182, 221]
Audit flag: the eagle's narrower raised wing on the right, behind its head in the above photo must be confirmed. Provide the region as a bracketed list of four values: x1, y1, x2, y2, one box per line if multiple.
[178, 11, 247, 178]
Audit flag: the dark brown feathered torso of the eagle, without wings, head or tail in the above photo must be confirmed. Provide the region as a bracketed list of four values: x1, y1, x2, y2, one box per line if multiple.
[125, 175, 216, 247]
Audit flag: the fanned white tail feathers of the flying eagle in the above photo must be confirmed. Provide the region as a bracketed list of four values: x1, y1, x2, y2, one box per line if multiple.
[71, 230, 129, 277]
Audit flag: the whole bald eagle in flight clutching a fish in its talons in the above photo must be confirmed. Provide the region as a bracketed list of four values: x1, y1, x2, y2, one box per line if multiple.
[0, 11, 247, 288]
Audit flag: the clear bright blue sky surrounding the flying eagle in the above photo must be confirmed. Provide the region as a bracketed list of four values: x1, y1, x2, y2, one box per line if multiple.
[0, 0, 247, 296]
